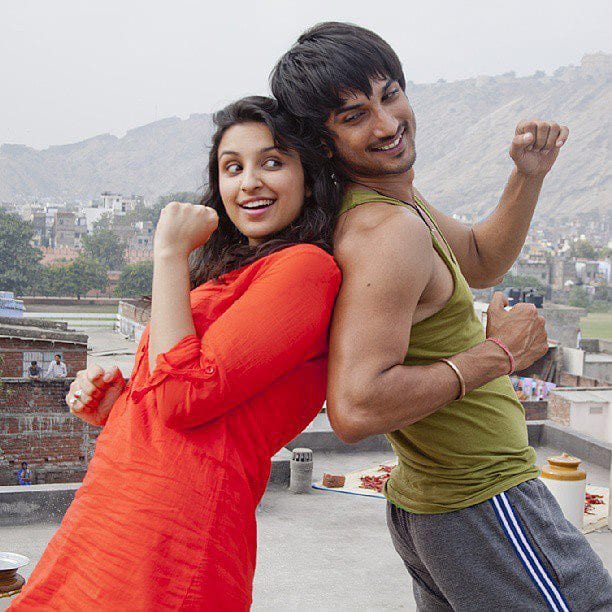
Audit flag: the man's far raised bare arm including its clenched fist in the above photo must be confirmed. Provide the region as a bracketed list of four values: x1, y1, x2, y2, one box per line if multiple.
[415, 121, 568, 288]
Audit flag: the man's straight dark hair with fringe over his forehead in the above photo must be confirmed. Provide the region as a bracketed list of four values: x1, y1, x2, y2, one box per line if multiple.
[270, 21, 406, 145]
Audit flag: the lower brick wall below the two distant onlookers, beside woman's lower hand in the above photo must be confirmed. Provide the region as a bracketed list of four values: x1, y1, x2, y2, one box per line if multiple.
[0, 379, 101, 485]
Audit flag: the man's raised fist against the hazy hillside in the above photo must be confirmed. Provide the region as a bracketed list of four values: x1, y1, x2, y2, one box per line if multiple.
[510, 120, 569, 177]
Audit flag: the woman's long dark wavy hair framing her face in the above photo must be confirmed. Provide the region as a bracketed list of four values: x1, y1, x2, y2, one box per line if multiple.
[189, 96, 340, 289]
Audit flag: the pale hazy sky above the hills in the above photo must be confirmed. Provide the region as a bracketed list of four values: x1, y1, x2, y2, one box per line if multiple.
[0, 0, 612, 148]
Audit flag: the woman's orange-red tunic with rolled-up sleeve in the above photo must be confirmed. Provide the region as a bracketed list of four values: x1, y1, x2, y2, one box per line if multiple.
[10, 245, 340, 611]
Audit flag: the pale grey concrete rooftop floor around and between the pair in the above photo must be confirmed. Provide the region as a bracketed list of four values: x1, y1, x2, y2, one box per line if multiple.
[0, 448, 612, 611]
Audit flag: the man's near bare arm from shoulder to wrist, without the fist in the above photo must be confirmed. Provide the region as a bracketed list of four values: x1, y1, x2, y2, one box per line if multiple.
[327, 205, 508, 443]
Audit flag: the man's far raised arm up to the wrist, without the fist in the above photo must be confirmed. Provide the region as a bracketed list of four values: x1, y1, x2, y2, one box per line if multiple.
[415, 169, 544, 288]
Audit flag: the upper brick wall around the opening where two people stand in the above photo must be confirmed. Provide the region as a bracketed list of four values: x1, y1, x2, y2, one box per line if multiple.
[0, 338, 87, 378]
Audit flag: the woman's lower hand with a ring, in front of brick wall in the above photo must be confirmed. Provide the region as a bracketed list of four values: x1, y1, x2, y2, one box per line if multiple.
[66, 365, 125, 427]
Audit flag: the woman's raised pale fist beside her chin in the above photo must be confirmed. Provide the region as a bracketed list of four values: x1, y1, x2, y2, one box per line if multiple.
[153, 202, 219, 257]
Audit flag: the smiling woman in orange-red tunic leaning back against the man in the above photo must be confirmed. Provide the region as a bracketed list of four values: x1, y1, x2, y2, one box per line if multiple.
[11, 97, 340, 610]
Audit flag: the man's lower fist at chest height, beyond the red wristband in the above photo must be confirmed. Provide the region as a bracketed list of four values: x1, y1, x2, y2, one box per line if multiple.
[487, 291, 548, 372]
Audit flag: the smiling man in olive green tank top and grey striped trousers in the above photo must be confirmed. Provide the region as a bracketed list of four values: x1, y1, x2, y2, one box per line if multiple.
[271, 23, 612, 611]
